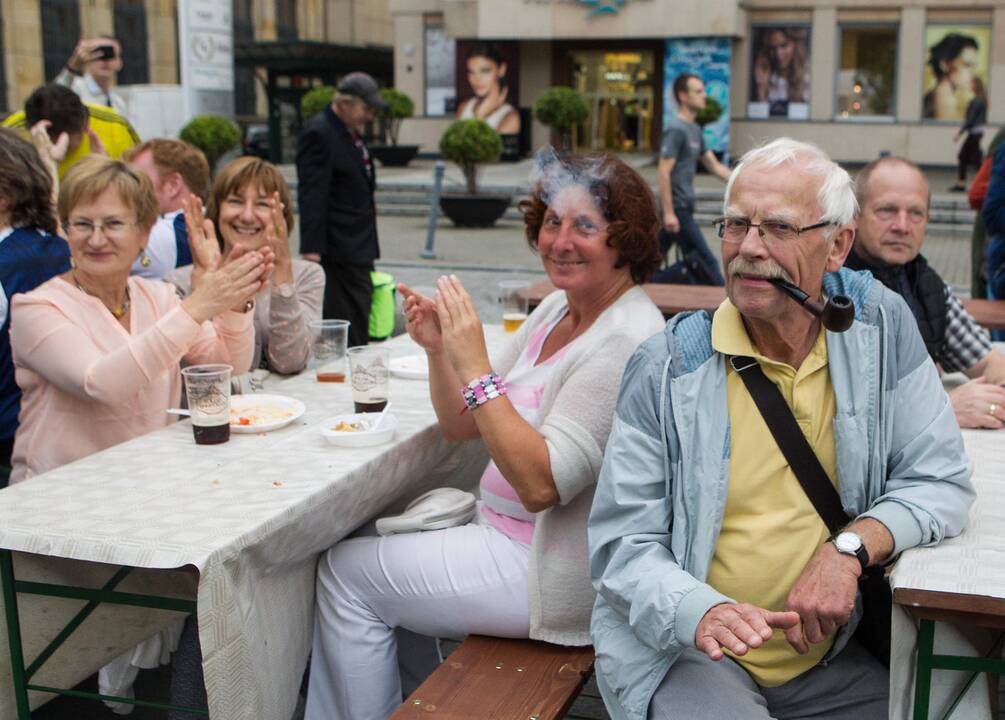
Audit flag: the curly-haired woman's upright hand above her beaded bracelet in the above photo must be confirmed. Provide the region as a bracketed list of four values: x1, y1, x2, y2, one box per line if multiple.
[436, 276, 491, 382]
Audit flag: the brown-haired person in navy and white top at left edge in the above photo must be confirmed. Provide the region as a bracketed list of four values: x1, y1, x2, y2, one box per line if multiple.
[0, 128, 69, 478]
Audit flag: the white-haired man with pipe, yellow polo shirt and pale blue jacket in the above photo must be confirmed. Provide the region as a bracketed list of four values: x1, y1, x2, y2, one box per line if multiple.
[588, 138, 974, 720]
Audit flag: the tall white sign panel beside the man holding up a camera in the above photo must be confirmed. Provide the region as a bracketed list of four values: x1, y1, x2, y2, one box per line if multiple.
[178, 0, 234, 118]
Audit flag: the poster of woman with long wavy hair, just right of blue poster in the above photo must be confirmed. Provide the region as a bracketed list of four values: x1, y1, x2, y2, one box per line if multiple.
[747, 25, 810, 120]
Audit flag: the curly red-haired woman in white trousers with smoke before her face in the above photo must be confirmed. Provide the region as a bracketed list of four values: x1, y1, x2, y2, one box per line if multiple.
[307, 152, 663, 720]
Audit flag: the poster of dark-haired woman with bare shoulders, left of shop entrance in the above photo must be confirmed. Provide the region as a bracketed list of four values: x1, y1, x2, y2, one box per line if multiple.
[456, 40, 520, 135]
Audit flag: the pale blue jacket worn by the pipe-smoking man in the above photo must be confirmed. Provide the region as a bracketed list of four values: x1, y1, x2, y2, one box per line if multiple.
[589, 269, 974, 720]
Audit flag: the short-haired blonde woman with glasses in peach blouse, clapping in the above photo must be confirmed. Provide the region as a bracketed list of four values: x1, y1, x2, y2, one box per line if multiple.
[10, 156, 273, 484]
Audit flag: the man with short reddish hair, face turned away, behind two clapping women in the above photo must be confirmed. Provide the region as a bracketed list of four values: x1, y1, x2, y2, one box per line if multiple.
[123, 138, 209, 280]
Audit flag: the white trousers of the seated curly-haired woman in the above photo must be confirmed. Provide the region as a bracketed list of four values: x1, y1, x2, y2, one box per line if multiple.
[306, 522, 530, 720]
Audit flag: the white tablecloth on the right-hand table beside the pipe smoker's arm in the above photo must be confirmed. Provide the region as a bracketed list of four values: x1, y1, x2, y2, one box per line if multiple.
[890, 430, 1005, 720]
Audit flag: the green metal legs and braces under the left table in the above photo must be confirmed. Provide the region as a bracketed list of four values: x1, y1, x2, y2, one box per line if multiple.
[0, 549, 206, 720]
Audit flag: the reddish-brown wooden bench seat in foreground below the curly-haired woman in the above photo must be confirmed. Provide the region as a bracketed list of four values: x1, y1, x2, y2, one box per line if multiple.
[391, 635, 593, 720]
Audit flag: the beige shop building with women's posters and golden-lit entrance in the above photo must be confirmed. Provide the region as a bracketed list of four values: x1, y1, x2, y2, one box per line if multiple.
[391, 0, 1005, 165]
